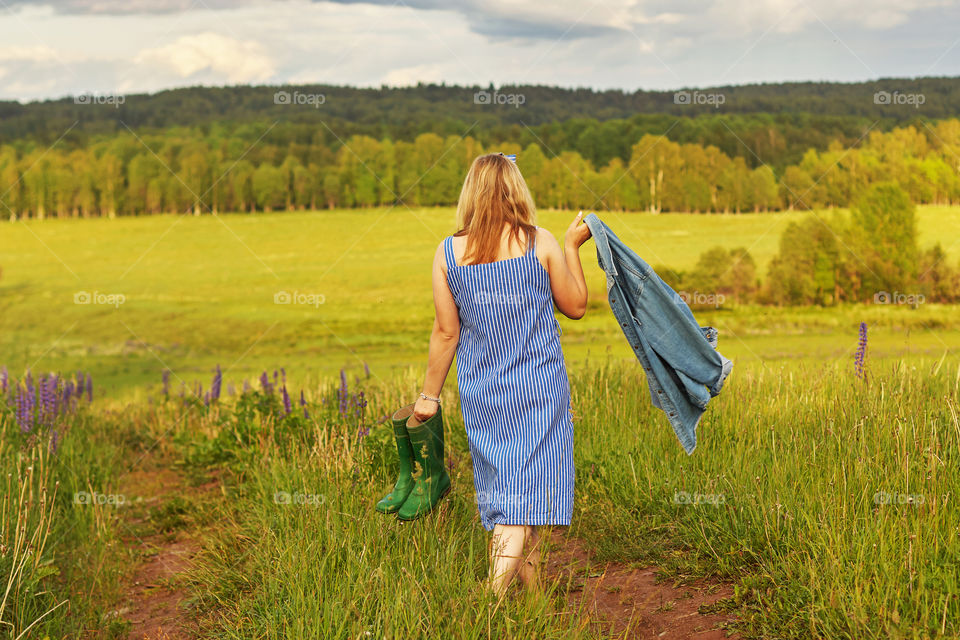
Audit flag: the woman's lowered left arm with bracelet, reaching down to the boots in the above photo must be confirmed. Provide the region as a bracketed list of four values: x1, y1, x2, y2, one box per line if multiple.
[413, 242, 460, 420]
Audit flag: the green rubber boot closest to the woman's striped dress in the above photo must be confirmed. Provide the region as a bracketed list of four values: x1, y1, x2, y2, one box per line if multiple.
[397, 407, 450, 520]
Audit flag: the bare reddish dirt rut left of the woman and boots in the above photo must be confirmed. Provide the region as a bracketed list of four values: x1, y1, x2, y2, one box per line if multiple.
[115, 458, 219, 640]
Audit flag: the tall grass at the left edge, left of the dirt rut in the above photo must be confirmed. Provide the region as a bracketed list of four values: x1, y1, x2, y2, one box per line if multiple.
[0, 370, 135, 639]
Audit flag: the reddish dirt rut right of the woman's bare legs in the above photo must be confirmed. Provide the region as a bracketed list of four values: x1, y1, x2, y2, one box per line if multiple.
[543, 531, 741, 640]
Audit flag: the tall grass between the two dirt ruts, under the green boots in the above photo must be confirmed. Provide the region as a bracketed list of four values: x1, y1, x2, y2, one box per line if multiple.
[142, 371, 590, 638]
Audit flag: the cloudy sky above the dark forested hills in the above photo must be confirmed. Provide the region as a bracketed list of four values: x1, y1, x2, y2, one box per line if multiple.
[0, 0, 960, 102]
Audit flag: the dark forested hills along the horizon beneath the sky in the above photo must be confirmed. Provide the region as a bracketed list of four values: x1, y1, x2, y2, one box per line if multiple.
[0, 77, 960, 145]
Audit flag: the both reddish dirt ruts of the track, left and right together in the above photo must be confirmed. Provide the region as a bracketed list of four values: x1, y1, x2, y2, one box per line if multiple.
[105, 458, 740, 640]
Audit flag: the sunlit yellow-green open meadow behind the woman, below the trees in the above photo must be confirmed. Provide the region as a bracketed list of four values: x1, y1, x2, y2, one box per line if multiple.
[0, 207, 960, 395]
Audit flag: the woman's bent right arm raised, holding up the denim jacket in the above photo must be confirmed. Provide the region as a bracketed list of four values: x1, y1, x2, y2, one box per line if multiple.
[538, 211, 590, 320]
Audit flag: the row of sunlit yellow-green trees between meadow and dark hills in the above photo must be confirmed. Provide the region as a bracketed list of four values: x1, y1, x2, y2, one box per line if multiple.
[0, 119, 960, 219]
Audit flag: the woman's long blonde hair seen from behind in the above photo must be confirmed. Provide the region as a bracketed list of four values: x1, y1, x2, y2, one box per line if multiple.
[453, 153, 537, 264]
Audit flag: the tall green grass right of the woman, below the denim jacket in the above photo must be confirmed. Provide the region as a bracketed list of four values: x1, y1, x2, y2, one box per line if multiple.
[574, 358, 960, 638]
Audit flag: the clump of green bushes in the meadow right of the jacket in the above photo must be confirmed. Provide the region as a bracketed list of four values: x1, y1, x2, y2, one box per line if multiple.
[654, 182, 960, 308]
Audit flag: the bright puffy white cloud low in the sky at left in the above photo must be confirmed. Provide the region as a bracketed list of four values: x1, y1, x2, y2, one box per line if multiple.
[133, 31, 276, 84]
